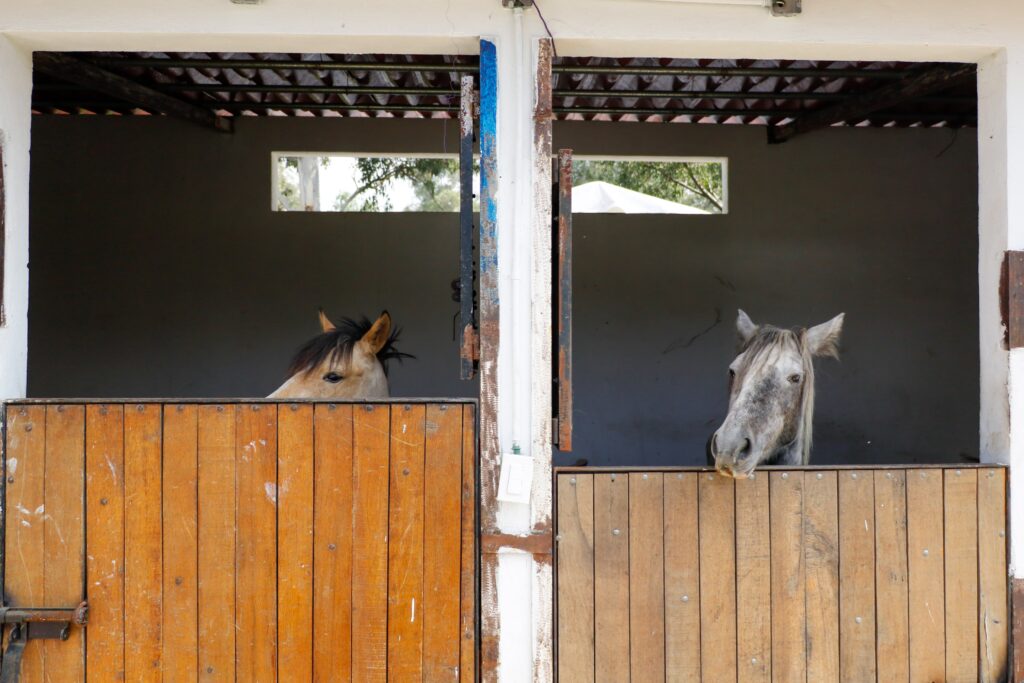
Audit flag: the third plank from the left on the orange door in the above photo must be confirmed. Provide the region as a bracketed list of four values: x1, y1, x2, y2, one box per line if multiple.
[85, 404, 125, 681]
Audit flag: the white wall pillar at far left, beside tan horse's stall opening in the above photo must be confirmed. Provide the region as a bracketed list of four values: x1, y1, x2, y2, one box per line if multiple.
[0, 36, 32, 398]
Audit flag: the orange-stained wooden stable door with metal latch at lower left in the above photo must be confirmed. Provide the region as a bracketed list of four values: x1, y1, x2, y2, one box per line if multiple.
[4, 402, 476, 683]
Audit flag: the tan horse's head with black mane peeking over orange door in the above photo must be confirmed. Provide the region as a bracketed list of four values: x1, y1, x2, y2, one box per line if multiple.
[267, 310, 414, 399]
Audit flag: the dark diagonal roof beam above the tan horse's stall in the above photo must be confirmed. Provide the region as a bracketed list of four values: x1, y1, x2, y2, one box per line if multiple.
[33, 52, 231, 133]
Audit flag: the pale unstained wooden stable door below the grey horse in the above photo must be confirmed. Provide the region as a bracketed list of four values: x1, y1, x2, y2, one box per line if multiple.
[555, 467, 1009, 683]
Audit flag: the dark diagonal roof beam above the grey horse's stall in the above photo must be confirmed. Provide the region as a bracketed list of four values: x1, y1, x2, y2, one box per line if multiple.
[768, 63, 977, 144]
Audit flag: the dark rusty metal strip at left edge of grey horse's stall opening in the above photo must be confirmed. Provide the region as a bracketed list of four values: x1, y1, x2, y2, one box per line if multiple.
[558, 150, 572, 452]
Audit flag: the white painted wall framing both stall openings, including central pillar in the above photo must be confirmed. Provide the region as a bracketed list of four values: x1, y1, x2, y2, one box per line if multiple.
[6, 0, 1024, 681]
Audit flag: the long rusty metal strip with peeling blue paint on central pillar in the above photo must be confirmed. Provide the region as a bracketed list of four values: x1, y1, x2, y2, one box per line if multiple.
[478, 40, 501, 683]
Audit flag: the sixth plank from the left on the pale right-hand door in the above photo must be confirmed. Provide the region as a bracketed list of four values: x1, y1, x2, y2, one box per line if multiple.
[737, 474, 770, 683]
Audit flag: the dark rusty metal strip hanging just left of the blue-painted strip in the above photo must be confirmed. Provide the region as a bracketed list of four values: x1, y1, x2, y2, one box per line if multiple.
[459, 76, 479, 380]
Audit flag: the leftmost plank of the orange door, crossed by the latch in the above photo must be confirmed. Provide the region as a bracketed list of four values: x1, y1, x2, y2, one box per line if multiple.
[4, 405, 47, 683]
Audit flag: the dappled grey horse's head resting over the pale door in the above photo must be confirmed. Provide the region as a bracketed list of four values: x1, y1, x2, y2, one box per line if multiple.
[708, 311, 843, 479]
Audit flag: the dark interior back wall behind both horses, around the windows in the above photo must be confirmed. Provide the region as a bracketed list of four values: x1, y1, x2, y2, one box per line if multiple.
[29, 117, 979, 465]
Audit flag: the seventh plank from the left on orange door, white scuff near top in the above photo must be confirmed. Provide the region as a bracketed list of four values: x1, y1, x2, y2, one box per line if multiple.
[234, 403, 278, 682]
